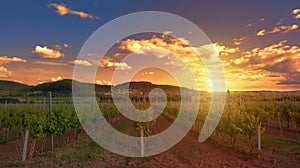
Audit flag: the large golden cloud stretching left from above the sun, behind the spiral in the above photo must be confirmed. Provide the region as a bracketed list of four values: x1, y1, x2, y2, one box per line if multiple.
[119, 32, 238, 65]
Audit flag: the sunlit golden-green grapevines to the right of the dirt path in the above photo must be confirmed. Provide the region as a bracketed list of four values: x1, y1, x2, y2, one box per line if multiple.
[166, 94, 300, 152]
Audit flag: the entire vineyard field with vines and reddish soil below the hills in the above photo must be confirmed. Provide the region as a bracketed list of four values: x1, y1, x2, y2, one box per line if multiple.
[0, 92, 300, 167]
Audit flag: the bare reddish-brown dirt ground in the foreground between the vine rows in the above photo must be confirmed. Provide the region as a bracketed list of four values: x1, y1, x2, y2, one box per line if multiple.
[0, 117, 300, 168]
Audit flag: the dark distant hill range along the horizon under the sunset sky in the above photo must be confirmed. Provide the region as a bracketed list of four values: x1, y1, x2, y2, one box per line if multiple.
[0, 79, 300, 99]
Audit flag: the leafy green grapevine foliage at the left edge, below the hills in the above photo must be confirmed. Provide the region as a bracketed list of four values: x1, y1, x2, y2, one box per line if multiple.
[0, 105, 82, 139]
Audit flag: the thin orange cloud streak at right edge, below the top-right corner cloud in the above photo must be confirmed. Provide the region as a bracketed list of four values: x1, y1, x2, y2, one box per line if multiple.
[256, 24, 299, 36]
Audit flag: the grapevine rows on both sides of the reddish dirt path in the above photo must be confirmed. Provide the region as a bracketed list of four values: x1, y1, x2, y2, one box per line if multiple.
[0, 93, 300, 167]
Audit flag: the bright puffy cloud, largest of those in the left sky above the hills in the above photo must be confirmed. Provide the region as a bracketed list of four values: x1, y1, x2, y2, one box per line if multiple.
[32, 45, 65, 58]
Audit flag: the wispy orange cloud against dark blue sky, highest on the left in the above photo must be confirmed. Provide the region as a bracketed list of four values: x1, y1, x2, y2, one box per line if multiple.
[49, 4, 100, 19]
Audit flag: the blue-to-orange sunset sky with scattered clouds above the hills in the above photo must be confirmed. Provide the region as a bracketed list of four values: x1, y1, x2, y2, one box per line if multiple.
[0, 0, 300, 91]
